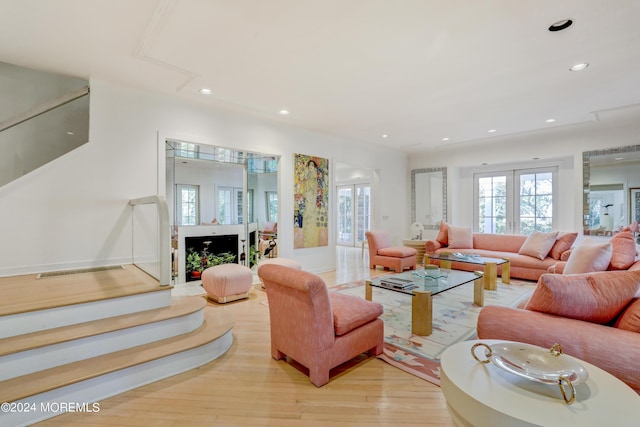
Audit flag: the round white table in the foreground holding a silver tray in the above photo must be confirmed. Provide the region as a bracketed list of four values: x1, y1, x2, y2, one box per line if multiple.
[440, 340, 640, 427]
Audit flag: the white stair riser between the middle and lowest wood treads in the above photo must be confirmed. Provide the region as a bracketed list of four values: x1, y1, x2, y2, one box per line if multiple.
[0, 310, 204, 381]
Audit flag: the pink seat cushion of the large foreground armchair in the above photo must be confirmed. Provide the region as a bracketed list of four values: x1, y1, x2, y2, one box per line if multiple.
[329, 292, 383, 336]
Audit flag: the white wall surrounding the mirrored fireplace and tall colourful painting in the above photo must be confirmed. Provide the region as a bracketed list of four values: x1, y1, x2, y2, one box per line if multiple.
[0, 81, 410, 276]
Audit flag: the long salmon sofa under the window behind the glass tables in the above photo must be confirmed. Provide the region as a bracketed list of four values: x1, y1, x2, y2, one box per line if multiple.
[425, 222, 578, 281]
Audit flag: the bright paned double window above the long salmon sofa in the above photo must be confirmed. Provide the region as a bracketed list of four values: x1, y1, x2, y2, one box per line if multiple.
[474, 167, 557, 235]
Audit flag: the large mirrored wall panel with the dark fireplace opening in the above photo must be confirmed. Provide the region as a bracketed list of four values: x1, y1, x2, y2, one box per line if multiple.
[165, 140, 279, 283]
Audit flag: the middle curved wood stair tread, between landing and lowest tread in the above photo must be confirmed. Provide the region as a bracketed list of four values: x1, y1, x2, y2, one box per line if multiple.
[0, 296, 207, 356]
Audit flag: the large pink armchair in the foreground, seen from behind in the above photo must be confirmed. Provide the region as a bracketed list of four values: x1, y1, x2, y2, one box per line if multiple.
[259, 264, 384, 387]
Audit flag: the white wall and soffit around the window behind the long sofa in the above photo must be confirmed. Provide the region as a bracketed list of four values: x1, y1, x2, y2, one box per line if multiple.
[408, 106, 640, 241]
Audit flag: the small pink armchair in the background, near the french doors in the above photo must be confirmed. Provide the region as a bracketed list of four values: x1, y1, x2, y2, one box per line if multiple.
[366, 230, 417, 273]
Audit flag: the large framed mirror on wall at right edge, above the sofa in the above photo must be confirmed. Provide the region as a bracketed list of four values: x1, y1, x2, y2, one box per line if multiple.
[582, 145, 640, 236]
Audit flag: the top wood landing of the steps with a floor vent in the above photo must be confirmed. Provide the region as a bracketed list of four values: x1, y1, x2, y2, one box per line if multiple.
[0, 265, 172, 316]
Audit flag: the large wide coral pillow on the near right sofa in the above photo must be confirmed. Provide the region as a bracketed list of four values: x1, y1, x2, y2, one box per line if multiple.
[525, 271, 640, 324]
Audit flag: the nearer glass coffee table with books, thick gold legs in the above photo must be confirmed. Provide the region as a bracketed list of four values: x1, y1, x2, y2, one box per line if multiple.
[365, 269, 484, 336]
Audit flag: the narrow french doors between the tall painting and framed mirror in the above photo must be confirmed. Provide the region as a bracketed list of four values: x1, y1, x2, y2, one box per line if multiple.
[336, 184, 371, 246]
